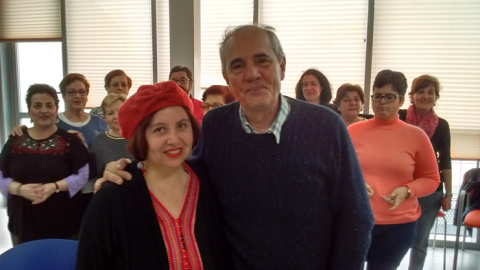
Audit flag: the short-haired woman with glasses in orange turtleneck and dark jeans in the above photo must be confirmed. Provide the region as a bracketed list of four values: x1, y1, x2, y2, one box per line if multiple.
[348, 70, 440, 270]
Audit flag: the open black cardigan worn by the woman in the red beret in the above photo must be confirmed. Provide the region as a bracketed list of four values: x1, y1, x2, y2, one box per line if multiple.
[77, 162, 233, 269]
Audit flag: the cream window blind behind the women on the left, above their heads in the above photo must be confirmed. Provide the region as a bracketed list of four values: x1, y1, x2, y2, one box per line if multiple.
[66, 0, 153, 108]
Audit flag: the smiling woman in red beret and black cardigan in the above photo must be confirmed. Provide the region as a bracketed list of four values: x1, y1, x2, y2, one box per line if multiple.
[77, 81, 232, 269]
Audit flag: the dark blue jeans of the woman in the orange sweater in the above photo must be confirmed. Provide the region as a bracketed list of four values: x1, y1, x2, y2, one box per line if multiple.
[367, 221, 417, 270]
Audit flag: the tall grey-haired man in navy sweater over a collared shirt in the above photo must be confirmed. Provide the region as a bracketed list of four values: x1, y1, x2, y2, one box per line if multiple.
[96, 25, 373, 270]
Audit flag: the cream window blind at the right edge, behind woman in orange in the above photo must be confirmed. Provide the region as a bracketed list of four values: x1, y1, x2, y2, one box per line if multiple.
[372, 0, 480, 159]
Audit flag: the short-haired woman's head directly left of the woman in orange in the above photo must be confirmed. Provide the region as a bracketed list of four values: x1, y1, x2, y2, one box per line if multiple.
[333, 83, 365, 127]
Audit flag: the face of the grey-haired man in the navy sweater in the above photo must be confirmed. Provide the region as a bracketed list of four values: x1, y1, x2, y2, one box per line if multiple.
[223, 26, 285, 111]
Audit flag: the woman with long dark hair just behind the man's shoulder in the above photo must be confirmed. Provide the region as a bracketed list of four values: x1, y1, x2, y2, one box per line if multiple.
[295, 68, 337, 111]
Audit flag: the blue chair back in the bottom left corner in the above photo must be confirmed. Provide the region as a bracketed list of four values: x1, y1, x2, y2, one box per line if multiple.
[0, 239, 78, 270]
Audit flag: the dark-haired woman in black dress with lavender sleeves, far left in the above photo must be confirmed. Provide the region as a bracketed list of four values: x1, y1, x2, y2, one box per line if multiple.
[0, 84, 89, 245]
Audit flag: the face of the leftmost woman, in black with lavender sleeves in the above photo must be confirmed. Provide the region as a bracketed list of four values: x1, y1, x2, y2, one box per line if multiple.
[28, 93, 58, 128]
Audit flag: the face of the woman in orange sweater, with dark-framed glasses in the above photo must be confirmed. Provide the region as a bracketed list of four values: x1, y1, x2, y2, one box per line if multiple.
[372, 84, 405, 121]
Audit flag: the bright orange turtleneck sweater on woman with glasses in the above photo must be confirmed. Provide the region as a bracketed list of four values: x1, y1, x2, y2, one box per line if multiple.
[348, 117, 440, 224]
